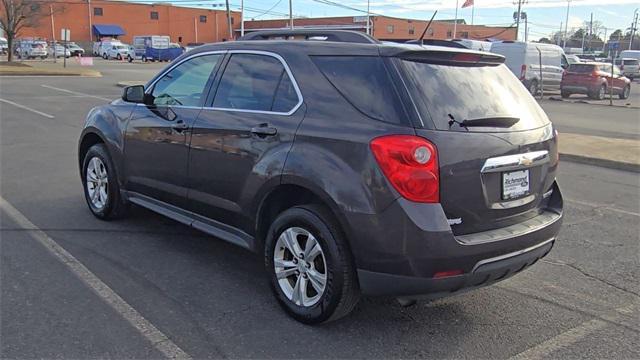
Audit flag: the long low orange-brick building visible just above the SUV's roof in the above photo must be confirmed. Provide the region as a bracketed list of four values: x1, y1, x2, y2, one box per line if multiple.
[245, 16, 516, 41]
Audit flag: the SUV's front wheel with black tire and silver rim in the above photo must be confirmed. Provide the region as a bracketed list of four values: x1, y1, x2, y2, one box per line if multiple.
[82, 144, 128, 220]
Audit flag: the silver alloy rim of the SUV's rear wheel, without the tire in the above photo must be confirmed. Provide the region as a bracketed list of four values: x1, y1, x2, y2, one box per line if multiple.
[273, 227, 327, 307]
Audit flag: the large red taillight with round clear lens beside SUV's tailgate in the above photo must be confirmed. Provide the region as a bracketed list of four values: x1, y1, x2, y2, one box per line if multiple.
[370, 135, 440, 203]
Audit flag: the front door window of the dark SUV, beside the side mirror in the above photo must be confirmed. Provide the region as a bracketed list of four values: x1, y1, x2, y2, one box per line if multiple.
[151, 54, 223, 106]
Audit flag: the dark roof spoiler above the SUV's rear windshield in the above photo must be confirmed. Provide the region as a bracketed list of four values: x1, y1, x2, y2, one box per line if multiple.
[389, 48, 505, 66]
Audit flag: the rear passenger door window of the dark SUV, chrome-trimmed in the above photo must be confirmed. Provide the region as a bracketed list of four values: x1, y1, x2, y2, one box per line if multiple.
[213, 54, 300, 113]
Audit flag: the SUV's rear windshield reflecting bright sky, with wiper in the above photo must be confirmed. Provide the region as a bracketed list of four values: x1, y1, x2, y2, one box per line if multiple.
[402, 60, 549, 132]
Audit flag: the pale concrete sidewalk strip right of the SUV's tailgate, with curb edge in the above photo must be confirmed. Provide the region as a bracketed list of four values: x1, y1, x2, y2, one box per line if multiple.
[559, 133, 640, 172]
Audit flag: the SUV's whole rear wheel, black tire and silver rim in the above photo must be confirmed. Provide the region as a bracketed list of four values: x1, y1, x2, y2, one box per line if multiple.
[264, 205, 360, 324]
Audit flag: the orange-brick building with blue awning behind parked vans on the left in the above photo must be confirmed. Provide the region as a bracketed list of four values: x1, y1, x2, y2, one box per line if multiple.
[20, 0, 240, 47]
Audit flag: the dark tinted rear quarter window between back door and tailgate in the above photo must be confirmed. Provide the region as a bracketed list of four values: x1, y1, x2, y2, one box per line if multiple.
[313, 56, 406, 123]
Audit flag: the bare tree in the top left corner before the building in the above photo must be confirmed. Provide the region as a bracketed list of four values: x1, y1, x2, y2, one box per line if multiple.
[0, 0, 63, 61]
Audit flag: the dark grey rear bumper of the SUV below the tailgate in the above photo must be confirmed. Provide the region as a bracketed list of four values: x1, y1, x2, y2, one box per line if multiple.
[350, 183, 563, 298]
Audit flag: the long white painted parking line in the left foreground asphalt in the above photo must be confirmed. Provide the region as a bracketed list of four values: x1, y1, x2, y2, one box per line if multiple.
[0, 196, 191, 359]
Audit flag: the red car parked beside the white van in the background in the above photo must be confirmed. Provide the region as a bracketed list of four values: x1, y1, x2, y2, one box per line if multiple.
[560, 62, 631, 100]
